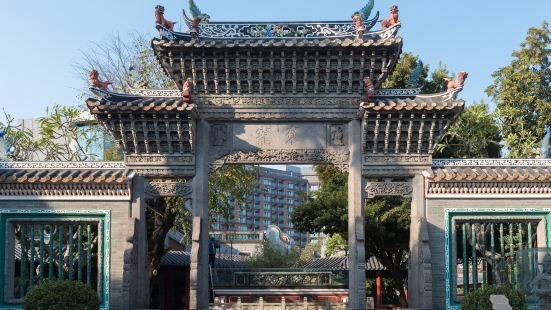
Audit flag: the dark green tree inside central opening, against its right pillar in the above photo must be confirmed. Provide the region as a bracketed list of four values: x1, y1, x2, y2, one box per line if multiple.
[291, 165, 348, 235]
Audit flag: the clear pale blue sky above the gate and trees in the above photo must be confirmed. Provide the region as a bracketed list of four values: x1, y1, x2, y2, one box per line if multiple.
[0, 0, 551, 118]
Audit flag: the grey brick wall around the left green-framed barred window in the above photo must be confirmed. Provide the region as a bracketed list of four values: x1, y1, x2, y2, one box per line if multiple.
[0, 200, 130, 309]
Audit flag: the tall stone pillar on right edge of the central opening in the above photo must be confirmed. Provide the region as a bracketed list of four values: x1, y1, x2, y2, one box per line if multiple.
[348, 120, 366, 309]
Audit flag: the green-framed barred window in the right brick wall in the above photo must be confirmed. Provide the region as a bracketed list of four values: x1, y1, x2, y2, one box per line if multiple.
[445, 209, 549, 307]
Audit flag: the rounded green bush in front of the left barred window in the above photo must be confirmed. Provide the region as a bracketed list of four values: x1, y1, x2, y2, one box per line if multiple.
[23, 281, 99, 310]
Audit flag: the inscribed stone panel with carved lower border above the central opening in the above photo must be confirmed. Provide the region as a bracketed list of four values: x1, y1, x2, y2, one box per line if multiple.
[209, 122, 349, 170]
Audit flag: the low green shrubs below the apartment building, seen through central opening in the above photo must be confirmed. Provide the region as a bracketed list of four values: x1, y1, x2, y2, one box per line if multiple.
[249, 239, 300, 268]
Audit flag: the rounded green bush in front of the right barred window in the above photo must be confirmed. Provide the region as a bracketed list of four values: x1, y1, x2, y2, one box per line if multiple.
[461, 286, 528, 310]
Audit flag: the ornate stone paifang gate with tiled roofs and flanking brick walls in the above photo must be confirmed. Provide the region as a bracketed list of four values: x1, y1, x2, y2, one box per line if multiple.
[0, 2, 551, 309]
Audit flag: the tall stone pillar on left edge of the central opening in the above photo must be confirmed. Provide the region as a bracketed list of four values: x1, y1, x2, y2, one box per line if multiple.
[189, 120, 209, 310]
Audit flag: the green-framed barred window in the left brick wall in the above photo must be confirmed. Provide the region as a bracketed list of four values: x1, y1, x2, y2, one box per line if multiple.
[0, 210, 111, 308]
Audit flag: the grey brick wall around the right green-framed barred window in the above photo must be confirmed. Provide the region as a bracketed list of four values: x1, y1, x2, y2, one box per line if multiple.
[427, 198, 551, 309]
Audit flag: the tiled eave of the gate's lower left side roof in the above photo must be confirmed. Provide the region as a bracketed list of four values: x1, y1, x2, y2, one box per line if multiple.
[86, 98, 195, 113]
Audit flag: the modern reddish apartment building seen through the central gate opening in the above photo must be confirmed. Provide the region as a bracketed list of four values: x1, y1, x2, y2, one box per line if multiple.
[211, 166, 309, 252]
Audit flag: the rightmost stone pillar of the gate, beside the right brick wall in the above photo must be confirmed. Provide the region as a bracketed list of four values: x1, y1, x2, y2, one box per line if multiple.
[408, 175, 432, 308]
